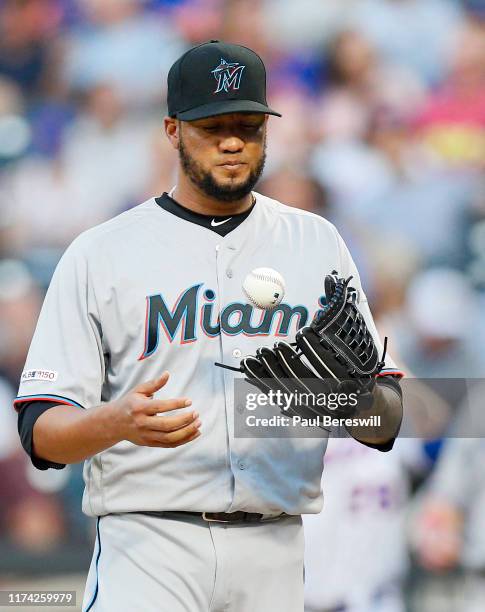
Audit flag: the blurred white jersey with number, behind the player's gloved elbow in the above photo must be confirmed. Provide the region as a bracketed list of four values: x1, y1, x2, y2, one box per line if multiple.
[303, 439, 422, 612]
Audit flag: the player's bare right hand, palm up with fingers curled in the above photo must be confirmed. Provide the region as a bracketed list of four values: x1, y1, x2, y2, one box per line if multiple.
[113, 372, 201, 448]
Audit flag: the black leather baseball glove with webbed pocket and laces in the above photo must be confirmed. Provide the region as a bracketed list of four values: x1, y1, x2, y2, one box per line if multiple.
[216, 271, 387, 426]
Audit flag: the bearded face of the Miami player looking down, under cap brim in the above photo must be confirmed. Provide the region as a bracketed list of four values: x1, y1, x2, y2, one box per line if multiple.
[179, 113, 267, 202]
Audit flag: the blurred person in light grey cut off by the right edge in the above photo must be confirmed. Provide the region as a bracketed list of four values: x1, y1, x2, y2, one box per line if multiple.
[411, 414, 485, 612]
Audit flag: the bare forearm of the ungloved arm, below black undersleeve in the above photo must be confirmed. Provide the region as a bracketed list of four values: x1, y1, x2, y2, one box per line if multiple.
[32, 403, 122, 463]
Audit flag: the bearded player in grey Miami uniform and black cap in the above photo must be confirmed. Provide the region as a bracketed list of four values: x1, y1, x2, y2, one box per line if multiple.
[15, 41, 402, 612]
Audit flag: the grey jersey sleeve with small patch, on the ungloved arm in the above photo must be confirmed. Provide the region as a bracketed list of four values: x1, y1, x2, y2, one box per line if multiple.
[14, 241, 104, 410]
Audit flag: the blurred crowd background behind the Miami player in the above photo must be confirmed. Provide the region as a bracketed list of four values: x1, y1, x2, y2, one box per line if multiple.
[0, 0, 485, 612]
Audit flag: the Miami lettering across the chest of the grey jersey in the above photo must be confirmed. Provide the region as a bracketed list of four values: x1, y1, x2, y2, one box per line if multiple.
[138, 283, 325, 360]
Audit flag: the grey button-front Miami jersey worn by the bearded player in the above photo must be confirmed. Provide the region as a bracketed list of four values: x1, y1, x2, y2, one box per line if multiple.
[16, 193, 395, 516]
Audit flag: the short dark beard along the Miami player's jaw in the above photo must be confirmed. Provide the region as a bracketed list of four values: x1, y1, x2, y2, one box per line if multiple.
[179, 135, 266, 202]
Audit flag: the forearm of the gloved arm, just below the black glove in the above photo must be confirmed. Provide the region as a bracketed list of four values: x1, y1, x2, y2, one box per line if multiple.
[346, 383, 403, 444]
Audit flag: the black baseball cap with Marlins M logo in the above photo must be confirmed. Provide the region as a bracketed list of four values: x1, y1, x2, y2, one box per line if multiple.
[167, 40, 281, 121]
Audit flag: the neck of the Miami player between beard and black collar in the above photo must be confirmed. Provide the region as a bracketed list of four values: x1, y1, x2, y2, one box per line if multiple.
[172, 172, 253, 216]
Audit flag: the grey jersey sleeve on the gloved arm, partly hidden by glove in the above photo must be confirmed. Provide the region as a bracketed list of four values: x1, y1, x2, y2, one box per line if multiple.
[335, 230, 404, 378]
